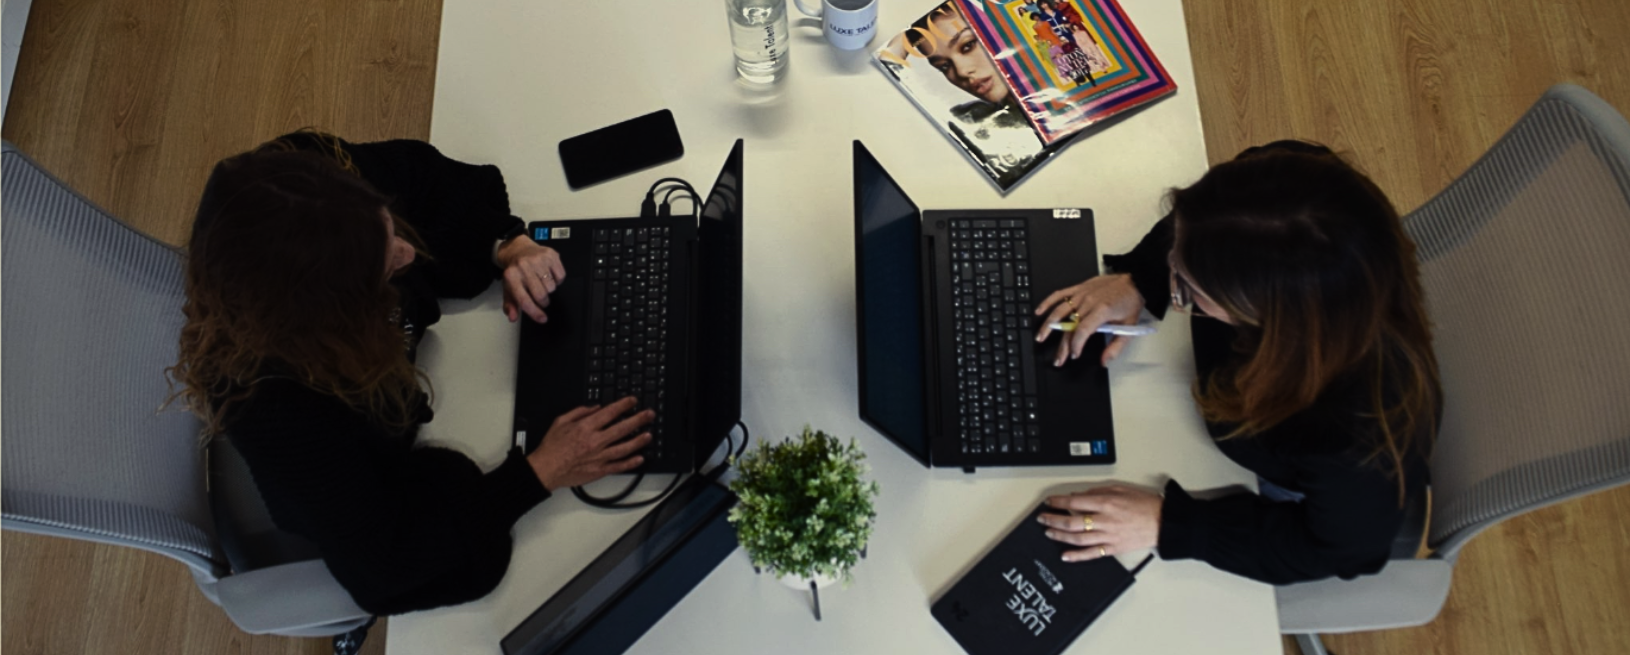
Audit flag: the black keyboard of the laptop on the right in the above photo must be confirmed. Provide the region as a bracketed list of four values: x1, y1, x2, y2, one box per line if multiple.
[950, 218, 1042, 453]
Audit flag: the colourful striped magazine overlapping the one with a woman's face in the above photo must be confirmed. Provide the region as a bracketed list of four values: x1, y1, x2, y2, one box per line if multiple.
[954, 0, 1177, 145]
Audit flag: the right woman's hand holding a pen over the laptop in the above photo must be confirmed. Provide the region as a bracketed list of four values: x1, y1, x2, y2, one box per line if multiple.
[1035, 274, 1143, 367]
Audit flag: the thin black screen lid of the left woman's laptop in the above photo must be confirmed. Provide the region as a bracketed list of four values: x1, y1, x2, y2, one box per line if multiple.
[696, 138, 743, 468]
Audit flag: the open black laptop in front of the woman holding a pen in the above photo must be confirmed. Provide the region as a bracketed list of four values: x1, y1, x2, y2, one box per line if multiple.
[854, 142, 1115, 471]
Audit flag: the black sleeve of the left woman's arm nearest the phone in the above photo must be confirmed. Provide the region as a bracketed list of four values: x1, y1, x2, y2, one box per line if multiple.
[346, 140, 522, 298]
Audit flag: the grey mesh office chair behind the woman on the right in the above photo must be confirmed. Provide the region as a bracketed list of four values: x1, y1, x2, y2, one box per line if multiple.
[1276, 85, 1630, 655]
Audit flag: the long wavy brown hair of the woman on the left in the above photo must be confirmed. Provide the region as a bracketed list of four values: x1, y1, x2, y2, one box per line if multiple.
[166, 142, 424, 437]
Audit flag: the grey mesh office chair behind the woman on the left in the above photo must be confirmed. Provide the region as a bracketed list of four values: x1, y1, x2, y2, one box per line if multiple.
[0, 143, 370, 637]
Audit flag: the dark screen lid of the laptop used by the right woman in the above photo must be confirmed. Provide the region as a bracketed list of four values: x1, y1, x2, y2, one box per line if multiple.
[854, 142, 929, 463]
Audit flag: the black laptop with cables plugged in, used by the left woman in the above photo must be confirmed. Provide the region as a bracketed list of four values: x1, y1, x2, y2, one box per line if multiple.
[513, 140, 742, 473]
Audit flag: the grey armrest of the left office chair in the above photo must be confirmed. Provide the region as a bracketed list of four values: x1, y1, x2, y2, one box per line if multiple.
[215, 559, 372, 637]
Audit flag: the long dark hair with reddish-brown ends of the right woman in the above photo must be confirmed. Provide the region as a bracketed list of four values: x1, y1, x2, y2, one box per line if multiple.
[1172, 142, 1441, 499]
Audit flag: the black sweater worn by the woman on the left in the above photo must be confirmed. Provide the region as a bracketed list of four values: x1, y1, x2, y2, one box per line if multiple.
[225, 135, 549, 614]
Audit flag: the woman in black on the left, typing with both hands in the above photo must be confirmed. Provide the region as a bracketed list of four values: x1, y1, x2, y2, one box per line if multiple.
[168, 132, 650, 628]
